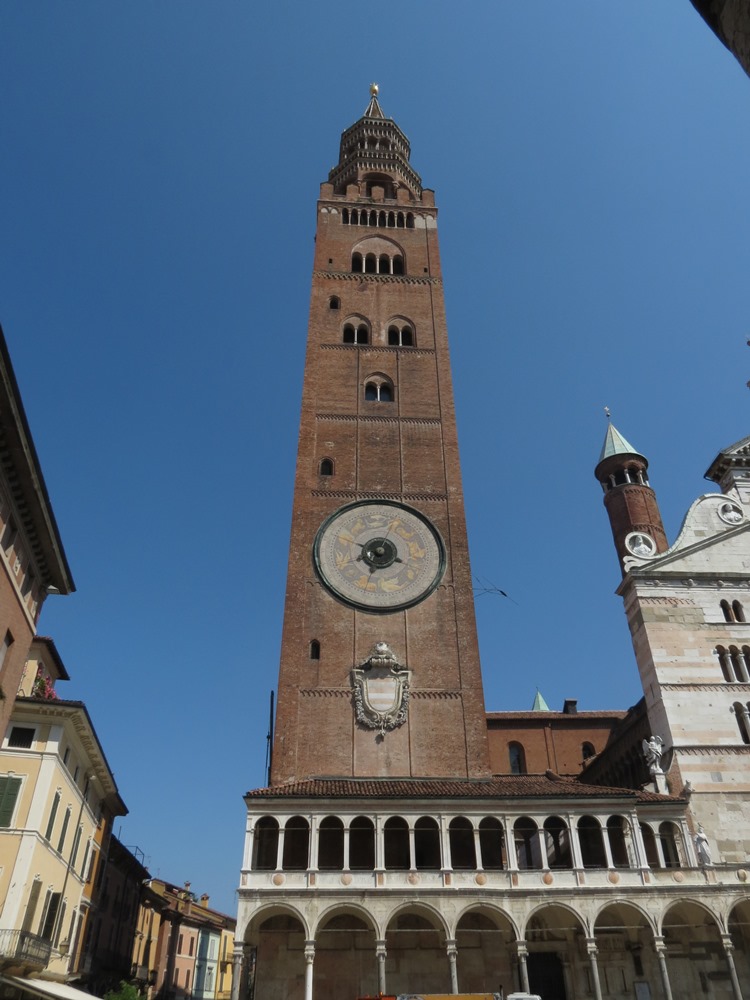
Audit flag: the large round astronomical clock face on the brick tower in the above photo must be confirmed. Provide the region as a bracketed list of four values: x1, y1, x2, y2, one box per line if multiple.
[314, 500, 445, 611]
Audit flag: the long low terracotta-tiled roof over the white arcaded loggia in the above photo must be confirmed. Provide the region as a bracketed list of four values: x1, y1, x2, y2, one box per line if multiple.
[246, 772, 682, 802]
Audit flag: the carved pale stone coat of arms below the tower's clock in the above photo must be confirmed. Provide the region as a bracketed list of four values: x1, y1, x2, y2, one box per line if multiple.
[352, 642, 411, 738]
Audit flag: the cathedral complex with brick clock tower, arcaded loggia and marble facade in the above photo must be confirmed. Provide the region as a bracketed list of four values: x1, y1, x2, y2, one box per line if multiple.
[233, 88, 750, 1000]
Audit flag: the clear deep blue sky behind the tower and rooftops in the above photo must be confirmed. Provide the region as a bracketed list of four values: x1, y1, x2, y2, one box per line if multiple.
[0, 0, 750, 912]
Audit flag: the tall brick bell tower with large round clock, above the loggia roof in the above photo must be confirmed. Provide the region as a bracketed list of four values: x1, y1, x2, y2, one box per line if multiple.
[271, 85, 490, 785]
